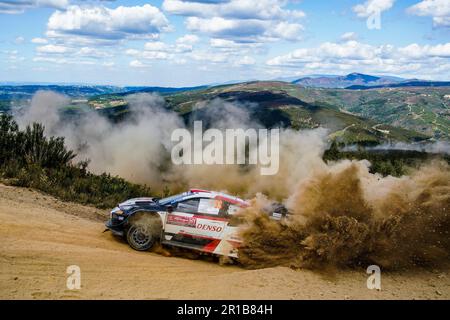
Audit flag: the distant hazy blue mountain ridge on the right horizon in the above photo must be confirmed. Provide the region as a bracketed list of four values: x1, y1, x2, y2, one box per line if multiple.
[292, 73, 405, 88]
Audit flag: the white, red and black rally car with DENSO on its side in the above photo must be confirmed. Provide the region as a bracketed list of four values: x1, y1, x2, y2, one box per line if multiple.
[106, 189, 287, 257]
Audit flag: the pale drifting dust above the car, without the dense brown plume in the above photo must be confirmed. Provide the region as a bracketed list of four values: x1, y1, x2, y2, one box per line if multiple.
[16, 91, 327, 200]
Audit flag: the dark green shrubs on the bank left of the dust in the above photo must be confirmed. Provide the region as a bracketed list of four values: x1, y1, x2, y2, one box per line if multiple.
[0, 114, 151, 208]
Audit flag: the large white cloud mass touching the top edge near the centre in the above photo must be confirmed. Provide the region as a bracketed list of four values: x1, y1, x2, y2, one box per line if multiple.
[163, 0, 305, 42]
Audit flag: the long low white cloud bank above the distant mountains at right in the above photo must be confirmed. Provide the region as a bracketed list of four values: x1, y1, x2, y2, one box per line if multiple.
[266, 40, 450, 76]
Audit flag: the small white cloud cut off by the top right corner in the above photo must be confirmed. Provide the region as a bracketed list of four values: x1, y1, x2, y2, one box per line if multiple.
[408, 0, 450, 27]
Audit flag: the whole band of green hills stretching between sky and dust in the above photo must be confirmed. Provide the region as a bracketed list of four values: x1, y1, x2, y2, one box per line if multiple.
[0, 80, 450, 144]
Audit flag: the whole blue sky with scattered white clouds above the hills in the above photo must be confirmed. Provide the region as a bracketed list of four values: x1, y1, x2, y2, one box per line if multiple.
[0, 0, 450, 86]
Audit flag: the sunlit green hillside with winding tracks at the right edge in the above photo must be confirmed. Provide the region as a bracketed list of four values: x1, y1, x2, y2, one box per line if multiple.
[295, 87, 450, 140]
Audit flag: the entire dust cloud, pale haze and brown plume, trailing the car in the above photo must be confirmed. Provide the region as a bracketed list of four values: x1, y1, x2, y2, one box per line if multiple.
[17, 92, 450, 268]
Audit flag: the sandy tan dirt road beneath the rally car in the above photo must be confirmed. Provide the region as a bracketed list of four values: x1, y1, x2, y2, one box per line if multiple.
[0, 185, 450, 299]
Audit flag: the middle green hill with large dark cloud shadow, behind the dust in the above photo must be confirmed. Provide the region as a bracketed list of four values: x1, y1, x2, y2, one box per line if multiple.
[89, 81, 428, 144]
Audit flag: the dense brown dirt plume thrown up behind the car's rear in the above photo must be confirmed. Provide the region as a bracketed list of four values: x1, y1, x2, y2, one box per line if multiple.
[239, 161, 450, 269]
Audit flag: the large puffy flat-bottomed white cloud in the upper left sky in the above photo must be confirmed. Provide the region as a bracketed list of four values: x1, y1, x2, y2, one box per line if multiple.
[47, 4, 171, 41]
